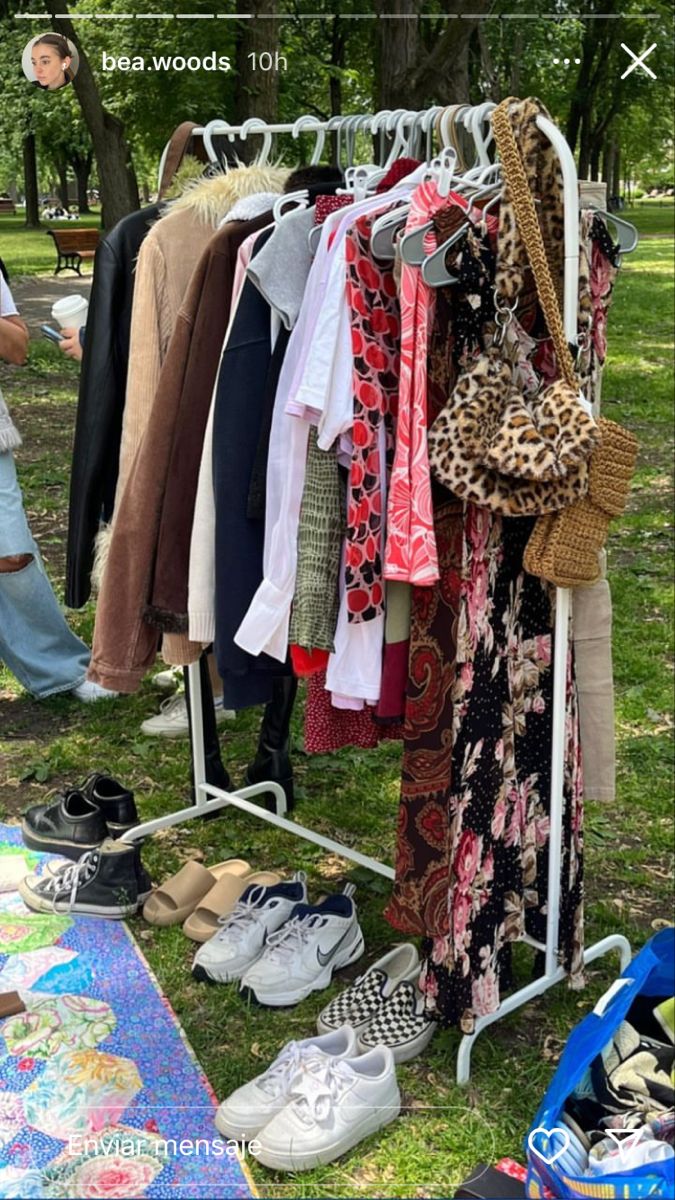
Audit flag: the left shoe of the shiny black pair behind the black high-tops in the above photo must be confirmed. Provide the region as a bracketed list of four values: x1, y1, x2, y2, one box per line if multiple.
[22, 787, 108, 859]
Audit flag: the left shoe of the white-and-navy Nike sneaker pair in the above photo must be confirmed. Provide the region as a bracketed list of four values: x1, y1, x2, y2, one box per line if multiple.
[192, 871, 307, 983]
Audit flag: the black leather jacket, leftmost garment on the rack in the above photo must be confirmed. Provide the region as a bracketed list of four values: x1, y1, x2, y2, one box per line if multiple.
[66, 204, 160, 608]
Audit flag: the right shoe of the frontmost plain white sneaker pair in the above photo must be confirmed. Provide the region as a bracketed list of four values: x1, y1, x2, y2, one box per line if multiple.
[256, 1046, 401, 1171]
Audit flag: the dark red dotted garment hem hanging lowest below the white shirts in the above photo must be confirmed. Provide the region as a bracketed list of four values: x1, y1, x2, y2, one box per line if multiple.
[305, 671, 404, 754]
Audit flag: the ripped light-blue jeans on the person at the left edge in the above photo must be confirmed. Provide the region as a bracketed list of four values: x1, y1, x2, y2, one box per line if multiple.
[0, 450, 89, 700]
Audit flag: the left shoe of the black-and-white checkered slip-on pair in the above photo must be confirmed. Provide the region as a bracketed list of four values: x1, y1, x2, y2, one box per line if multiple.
[316, 942, 422, 1033]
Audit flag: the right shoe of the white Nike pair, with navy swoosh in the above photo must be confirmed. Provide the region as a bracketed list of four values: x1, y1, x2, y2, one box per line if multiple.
[241, 883, 364, 1008]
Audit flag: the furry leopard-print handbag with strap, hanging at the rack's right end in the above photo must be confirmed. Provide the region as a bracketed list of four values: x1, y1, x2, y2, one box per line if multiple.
[429, 101, 599, 516]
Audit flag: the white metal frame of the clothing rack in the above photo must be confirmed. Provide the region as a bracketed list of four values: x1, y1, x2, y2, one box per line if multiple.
[130, 103, 632, 1084]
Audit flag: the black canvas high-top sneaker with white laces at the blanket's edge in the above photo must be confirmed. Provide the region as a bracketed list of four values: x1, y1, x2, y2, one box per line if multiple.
[19, 838, 138, 920]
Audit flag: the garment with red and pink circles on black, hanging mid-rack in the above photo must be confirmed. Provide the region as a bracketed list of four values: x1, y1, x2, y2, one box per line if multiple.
[345, 215, 401, 622]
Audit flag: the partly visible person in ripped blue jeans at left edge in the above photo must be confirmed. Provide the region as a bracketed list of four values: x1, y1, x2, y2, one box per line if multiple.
[0, 276, 110, 701]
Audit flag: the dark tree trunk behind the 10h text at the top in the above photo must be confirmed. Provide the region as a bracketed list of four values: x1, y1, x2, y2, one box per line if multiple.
[234, 0, 279, 162]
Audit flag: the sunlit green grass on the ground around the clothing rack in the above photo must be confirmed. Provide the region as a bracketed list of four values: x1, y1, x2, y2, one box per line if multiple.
[0, 209, 673, 1196]
